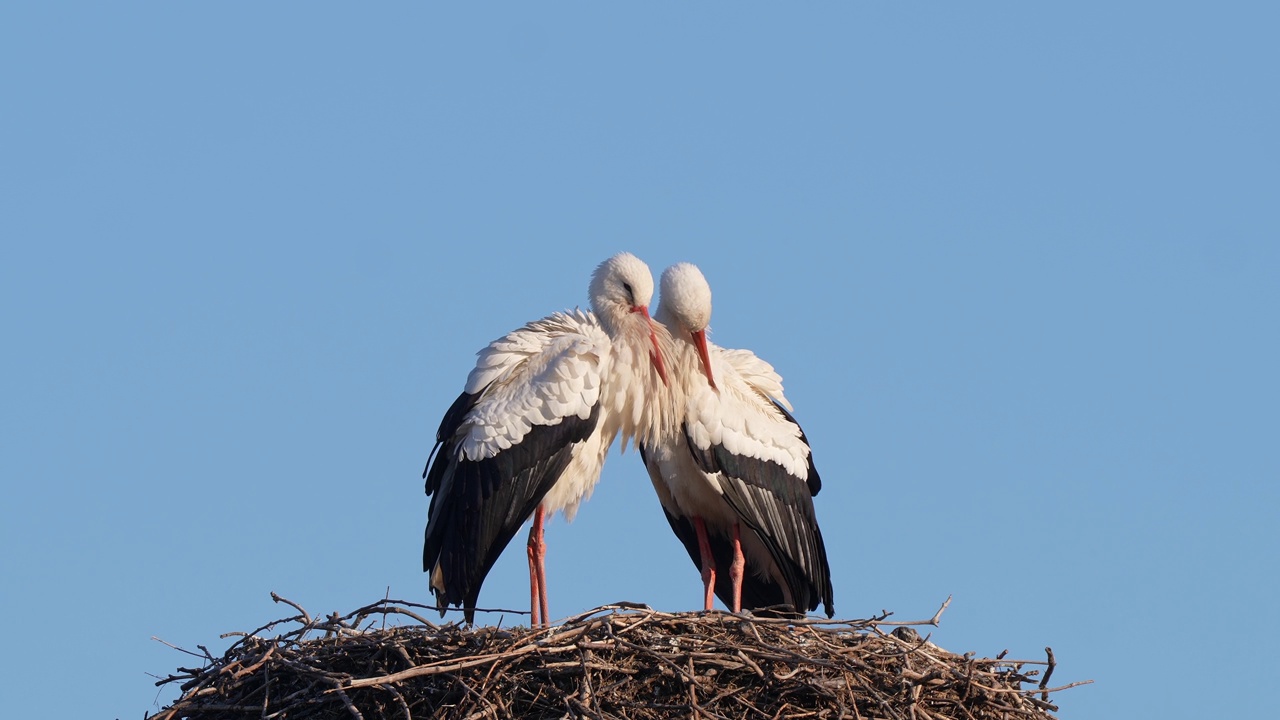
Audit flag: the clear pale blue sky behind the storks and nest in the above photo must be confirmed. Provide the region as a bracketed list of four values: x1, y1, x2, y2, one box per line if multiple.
[0, 1, 1280, 719]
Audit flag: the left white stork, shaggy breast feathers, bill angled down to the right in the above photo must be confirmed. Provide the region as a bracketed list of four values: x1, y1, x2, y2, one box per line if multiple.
[422, 252, 673, 625]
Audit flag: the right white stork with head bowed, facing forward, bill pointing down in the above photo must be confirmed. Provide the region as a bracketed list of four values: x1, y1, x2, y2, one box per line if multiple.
[640, 263, 833, 618]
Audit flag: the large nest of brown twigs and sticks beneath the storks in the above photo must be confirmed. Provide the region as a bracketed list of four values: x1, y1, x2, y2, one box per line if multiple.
[151, 593, 1084, 720]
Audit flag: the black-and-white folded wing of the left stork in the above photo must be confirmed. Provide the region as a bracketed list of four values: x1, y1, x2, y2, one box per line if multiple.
[422, 311, 611, 623]
